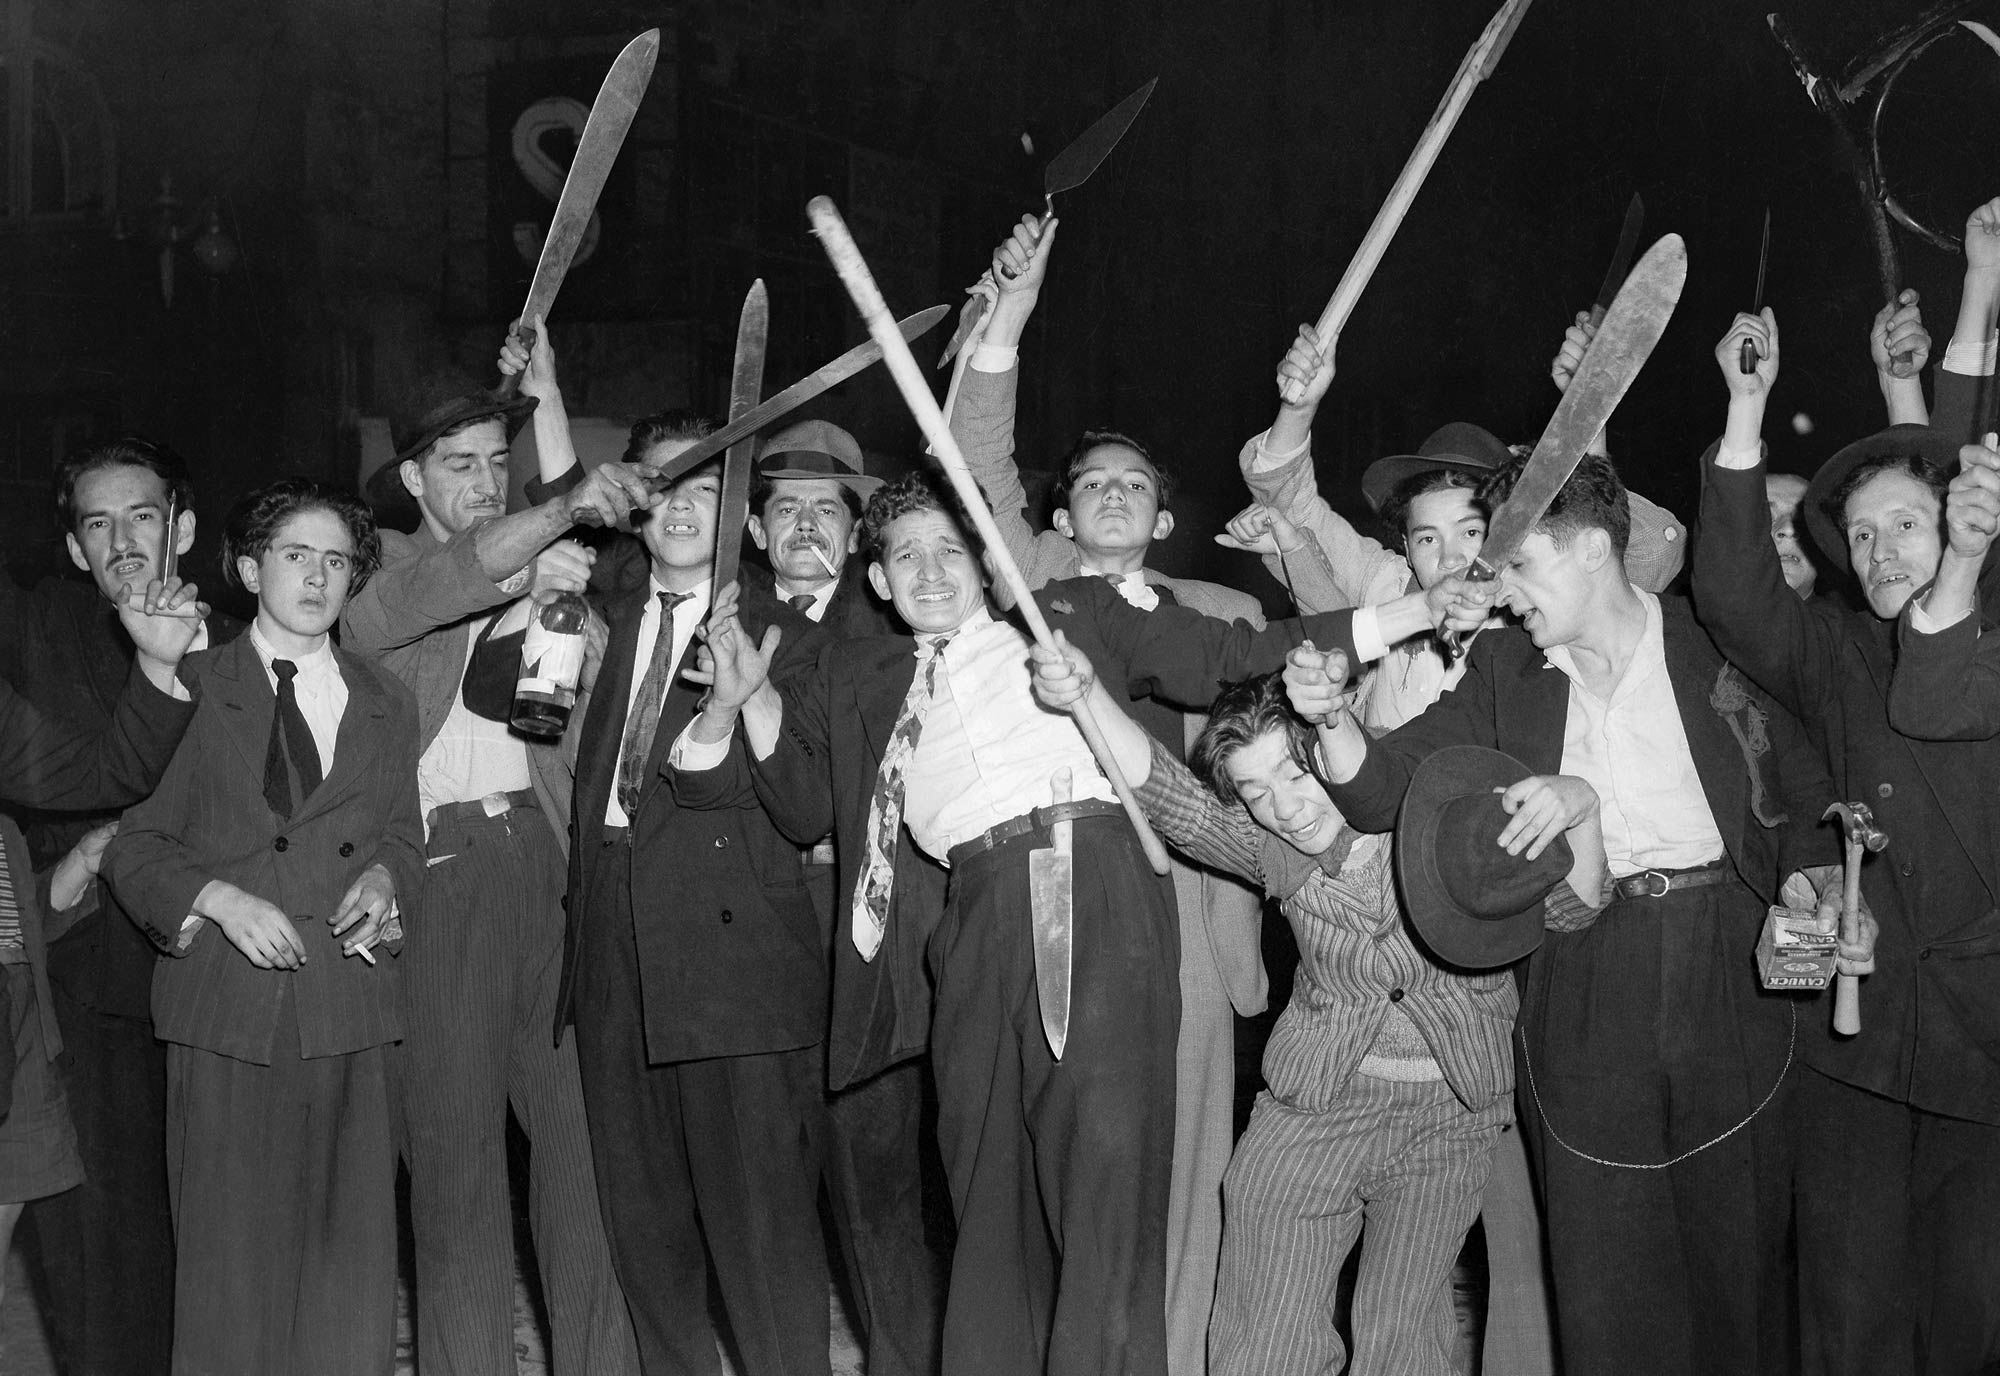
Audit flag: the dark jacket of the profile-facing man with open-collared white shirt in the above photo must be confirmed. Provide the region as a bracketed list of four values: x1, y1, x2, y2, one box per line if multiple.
[1330, 596, 1838, 908]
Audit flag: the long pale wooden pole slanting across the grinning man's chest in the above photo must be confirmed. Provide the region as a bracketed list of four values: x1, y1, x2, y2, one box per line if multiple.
[806, 196, 1168, 874]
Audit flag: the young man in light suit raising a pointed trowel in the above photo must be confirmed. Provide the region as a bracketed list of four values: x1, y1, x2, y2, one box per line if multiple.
[952, 216, 1268, 1376]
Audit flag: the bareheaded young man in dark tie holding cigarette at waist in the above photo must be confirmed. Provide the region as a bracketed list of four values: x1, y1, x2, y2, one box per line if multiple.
[104, 478, 424, 1376]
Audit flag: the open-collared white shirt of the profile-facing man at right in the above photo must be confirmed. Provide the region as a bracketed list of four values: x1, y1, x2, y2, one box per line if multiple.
[1546, 588, 1722, 878]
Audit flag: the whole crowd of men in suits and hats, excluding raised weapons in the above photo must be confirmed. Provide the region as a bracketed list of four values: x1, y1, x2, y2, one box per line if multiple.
[0, 191, 2000, 1376]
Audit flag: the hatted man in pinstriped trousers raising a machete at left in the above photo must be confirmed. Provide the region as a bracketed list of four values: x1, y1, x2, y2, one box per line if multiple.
[340, 358, 646, 1376]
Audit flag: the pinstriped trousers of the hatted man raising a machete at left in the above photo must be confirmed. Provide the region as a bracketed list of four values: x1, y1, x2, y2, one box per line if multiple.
[390, 808, 638, 1376]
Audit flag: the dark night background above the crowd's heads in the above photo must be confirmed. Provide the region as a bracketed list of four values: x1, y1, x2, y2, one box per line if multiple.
[0, 0, 2000, 600]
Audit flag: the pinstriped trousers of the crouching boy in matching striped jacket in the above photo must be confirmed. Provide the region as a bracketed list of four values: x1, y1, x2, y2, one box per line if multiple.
[1208, 1074, 1514, 1376]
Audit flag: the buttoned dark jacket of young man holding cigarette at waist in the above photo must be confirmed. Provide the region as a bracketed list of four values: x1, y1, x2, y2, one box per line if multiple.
[104, 636, 424, 1066]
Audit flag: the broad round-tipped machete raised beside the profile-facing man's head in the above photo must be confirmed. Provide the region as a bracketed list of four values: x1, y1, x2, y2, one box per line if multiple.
[1442, 234, 1688, 658]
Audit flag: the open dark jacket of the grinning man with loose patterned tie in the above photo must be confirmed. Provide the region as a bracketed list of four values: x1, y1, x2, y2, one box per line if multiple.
[744, 578, 1352, 1090]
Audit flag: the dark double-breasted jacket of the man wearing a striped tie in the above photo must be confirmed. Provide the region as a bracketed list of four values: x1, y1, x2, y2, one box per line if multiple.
[556, 560, 826, 1064]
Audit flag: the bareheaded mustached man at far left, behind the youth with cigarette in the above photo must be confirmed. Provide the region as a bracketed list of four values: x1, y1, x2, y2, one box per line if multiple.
[0, 436, 238, 1376]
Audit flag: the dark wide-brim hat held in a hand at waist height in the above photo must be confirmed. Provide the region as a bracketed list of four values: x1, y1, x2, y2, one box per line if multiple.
[1396, 746, 1576, 970]
